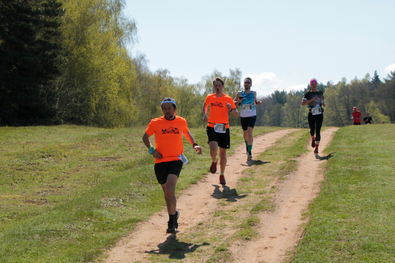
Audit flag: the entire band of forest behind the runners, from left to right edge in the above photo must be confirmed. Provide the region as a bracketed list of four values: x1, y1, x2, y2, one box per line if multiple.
[0, 0, 395, 128]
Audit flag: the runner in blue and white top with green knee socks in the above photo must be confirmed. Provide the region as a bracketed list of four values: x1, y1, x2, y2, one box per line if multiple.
[235, 78, 262, 159]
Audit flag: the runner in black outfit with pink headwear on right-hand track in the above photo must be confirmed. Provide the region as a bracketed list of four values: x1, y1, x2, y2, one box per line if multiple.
[302, 79, 325, 154]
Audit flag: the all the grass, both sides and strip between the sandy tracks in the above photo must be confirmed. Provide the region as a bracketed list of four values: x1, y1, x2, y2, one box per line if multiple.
[0, 125, 395, 263]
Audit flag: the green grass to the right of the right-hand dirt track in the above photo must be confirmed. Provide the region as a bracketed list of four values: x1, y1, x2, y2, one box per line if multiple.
[292, 125, 395, 262]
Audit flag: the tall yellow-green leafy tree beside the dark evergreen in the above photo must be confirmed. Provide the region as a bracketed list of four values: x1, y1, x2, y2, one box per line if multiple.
[53, 0, 137, 127]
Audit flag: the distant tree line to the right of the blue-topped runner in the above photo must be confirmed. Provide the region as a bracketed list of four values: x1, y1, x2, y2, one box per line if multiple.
[256, 71, 395, 128]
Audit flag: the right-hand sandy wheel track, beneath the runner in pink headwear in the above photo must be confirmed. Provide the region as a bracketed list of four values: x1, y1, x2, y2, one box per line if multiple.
[231, 128, 337, 263]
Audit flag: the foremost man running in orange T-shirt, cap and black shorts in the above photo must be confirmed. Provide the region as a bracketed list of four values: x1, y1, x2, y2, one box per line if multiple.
[143, 98, 202, 233]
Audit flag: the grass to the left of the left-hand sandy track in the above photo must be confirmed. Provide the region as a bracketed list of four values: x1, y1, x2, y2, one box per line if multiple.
[0, 125, 278, 263]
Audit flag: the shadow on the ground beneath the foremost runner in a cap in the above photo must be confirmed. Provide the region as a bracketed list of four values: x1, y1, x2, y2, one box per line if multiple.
[145, 234, 210, 259]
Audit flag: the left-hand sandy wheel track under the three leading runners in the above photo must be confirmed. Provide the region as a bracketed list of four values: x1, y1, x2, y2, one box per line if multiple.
[106, 129, 294, 263]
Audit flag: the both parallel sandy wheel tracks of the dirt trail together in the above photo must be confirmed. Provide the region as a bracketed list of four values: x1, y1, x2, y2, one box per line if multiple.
[106, 129, 336, 263]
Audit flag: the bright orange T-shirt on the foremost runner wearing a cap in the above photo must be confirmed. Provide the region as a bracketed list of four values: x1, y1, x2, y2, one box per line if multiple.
[145, 116, 189, 163]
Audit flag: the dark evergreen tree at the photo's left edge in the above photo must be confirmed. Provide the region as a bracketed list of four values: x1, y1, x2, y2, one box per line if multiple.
[0, 0, 61, 125]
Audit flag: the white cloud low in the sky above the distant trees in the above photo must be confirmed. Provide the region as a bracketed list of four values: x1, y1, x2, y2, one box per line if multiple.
[243, 72, 307, 97]
